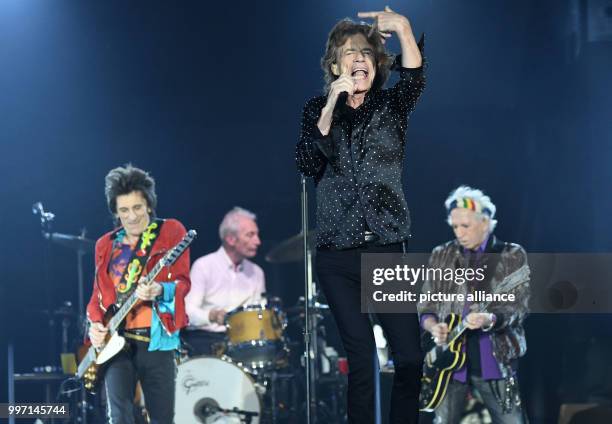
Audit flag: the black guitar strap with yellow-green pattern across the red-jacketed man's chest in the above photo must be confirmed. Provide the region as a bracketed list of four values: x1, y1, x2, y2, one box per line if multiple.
[115, 219, 164, 308]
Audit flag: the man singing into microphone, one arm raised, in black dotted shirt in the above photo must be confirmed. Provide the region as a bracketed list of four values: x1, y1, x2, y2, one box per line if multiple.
[296, 7, 425, 424]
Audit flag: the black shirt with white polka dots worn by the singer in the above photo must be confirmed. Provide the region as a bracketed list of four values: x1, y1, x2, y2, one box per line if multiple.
[296, 50, 425, 249]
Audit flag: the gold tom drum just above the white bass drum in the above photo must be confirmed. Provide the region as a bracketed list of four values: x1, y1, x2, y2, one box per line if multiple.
[225, 305, 287, 370]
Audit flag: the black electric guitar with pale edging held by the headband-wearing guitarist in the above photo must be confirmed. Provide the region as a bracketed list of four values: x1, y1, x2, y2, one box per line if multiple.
[419, 266, 529, 412]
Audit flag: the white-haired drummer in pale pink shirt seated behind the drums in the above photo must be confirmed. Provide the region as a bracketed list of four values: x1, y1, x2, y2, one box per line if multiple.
[183, 207, 266, 355]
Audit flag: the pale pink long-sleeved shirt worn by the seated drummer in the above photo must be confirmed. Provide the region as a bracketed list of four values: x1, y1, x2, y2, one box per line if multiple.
[185, 246, 266, 332]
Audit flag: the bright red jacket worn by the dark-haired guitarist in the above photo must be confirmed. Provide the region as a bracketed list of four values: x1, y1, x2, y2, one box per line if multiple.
[87, 219, 191, 333]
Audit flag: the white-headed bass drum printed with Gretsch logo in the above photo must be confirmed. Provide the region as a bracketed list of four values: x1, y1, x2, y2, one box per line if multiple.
[174, 356, 262, 424]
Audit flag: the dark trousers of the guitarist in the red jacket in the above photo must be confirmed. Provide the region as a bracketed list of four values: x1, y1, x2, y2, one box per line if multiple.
[104, 339, 176, 424]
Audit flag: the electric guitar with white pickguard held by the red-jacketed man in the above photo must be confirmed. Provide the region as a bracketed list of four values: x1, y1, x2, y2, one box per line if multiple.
[76, 230, 197, 391]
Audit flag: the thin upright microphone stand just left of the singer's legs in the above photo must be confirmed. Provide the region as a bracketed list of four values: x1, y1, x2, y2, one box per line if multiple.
[301, 175, 317, 424]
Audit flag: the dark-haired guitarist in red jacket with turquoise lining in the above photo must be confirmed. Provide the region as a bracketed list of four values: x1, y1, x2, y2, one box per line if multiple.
[87, 165, 190, 424]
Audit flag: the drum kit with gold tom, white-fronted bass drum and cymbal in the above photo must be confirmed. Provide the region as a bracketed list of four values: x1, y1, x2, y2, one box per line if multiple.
[174, 235, 348, 424]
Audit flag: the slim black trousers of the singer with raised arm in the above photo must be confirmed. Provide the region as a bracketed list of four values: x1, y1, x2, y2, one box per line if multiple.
[316, 243, 423, 424]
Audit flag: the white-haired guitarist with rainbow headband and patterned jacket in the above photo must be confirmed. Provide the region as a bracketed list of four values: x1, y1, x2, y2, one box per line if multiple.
[418, 186, 529, 424]
